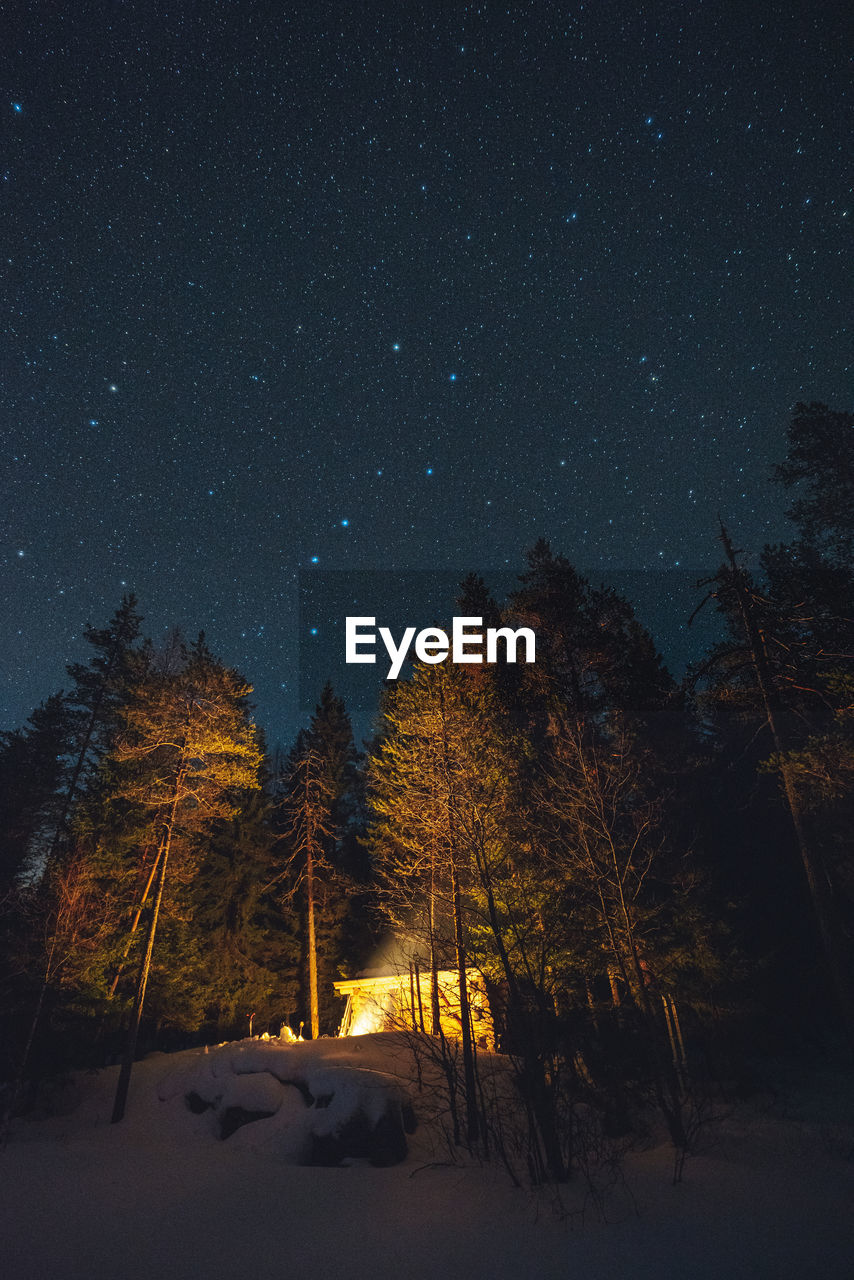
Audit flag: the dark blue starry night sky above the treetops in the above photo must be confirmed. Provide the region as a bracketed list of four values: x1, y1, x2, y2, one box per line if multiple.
[0, 0, 854, 741]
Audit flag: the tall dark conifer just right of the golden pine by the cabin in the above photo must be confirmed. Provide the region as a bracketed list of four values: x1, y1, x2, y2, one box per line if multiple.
[507, 540, 694, 1167]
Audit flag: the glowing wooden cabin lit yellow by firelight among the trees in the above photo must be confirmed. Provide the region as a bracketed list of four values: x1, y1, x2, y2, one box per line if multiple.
[334, 965, 494, 1050]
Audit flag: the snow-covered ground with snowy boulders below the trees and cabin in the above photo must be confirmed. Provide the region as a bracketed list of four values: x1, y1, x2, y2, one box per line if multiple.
[0, 1036, 854, 1280]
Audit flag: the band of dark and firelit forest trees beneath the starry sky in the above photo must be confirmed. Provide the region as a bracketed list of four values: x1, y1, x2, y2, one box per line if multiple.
[0, 404, 854, 1179]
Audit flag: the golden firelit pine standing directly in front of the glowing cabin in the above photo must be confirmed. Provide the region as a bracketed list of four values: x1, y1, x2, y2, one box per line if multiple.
[369, 664, 522, 1143]
